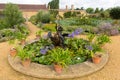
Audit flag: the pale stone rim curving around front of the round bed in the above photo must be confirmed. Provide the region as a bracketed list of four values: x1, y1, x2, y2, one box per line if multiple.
[8, 53, 109, 79]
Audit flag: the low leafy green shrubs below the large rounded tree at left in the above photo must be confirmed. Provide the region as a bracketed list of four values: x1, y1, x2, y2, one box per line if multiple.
[0, 25, 29, 42]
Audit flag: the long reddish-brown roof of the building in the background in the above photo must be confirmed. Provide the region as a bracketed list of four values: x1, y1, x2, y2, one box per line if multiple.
[0, 4, 47, 11]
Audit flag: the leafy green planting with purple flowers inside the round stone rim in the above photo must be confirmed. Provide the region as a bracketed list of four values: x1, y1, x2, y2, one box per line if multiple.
[14, 26, 110, 73]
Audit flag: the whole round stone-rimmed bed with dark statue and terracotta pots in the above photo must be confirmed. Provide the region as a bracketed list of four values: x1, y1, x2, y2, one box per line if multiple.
[8, 26, 110, 79]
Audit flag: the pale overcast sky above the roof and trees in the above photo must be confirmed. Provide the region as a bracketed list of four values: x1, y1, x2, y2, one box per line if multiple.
[0, 0, 120, 9]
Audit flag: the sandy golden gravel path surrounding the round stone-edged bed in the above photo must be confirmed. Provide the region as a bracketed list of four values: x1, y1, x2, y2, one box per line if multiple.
[0, 22, 120, 80]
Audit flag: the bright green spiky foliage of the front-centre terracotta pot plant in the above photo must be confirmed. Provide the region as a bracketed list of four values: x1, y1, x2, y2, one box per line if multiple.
[49, 48, 72, 67]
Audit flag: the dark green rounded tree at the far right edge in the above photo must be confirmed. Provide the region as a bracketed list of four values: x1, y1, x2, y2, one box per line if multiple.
[110, 7, 120, 19]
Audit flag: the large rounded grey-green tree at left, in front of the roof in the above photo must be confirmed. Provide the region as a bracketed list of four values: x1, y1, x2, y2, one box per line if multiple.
[3, 3, 24, 28]
